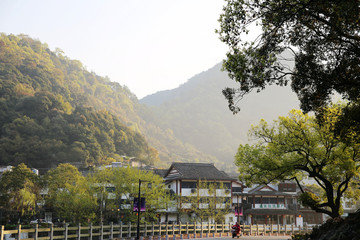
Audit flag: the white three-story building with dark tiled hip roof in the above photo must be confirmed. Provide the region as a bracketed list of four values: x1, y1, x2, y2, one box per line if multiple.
[161, 163, 236, 223]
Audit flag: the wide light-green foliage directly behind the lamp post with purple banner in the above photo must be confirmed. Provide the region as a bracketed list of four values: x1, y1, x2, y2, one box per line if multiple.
[87, 167, 171, 222]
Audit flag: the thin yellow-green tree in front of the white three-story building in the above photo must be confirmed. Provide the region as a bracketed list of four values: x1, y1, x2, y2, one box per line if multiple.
[181, 180, 231, 223]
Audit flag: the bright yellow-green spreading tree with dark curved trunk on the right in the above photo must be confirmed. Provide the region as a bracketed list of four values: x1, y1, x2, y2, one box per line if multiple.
[235, 106, 360, 218]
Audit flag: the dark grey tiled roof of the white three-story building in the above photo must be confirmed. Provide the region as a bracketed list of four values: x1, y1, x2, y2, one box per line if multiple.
[165, 163, 235, 181]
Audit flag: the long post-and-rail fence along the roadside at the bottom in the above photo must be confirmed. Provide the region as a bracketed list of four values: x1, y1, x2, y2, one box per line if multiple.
[0, 223, 311, 240]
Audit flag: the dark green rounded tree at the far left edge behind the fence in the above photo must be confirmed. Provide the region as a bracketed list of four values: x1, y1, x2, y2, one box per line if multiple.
[0, 163, 41, 223]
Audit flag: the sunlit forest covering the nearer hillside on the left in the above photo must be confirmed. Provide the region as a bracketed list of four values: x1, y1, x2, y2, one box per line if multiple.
[0, 34, 217, 169]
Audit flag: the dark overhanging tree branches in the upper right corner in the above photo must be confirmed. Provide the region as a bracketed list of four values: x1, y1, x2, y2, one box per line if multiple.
[218, 0, 360, 113]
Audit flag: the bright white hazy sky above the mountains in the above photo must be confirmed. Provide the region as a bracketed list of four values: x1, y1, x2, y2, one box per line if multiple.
[0, 0, 227, 98]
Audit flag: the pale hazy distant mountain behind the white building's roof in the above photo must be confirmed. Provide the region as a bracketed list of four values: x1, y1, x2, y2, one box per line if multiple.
[140, 61, 299, 170]
